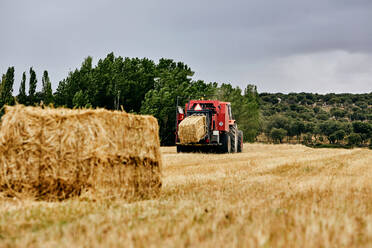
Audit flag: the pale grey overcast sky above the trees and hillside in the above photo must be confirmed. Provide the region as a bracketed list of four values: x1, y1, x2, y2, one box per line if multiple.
[0, 0, 372, 93]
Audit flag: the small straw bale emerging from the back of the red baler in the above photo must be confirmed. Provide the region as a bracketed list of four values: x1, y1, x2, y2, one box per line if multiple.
[178, 115, 207, 144]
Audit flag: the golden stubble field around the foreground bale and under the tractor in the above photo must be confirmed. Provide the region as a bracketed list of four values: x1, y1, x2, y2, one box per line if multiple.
[0, 144, 372, 247]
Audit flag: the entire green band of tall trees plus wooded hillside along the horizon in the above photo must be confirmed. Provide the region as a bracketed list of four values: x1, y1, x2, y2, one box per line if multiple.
[0, 53, 372, 146]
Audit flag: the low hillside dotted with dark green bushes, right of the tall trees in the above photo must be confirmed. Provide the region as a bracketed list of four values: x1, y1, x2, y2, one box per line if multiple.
[257, 93, 372, 146]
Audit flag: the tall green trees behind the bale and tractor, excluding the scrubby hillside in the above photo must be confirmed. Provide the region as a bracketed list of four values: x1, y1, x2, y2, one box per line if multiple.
[0, 53, 259, 145]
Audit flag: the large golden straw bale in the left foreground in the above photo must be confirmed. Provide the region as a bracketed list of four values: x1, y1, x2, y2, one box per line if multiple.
[0, 105, 161, 200]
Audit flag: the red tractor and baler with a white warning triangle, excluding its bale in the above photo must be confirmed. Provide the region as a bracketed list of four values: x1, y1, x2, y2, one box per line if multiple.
[176, 100, 243, 153]
